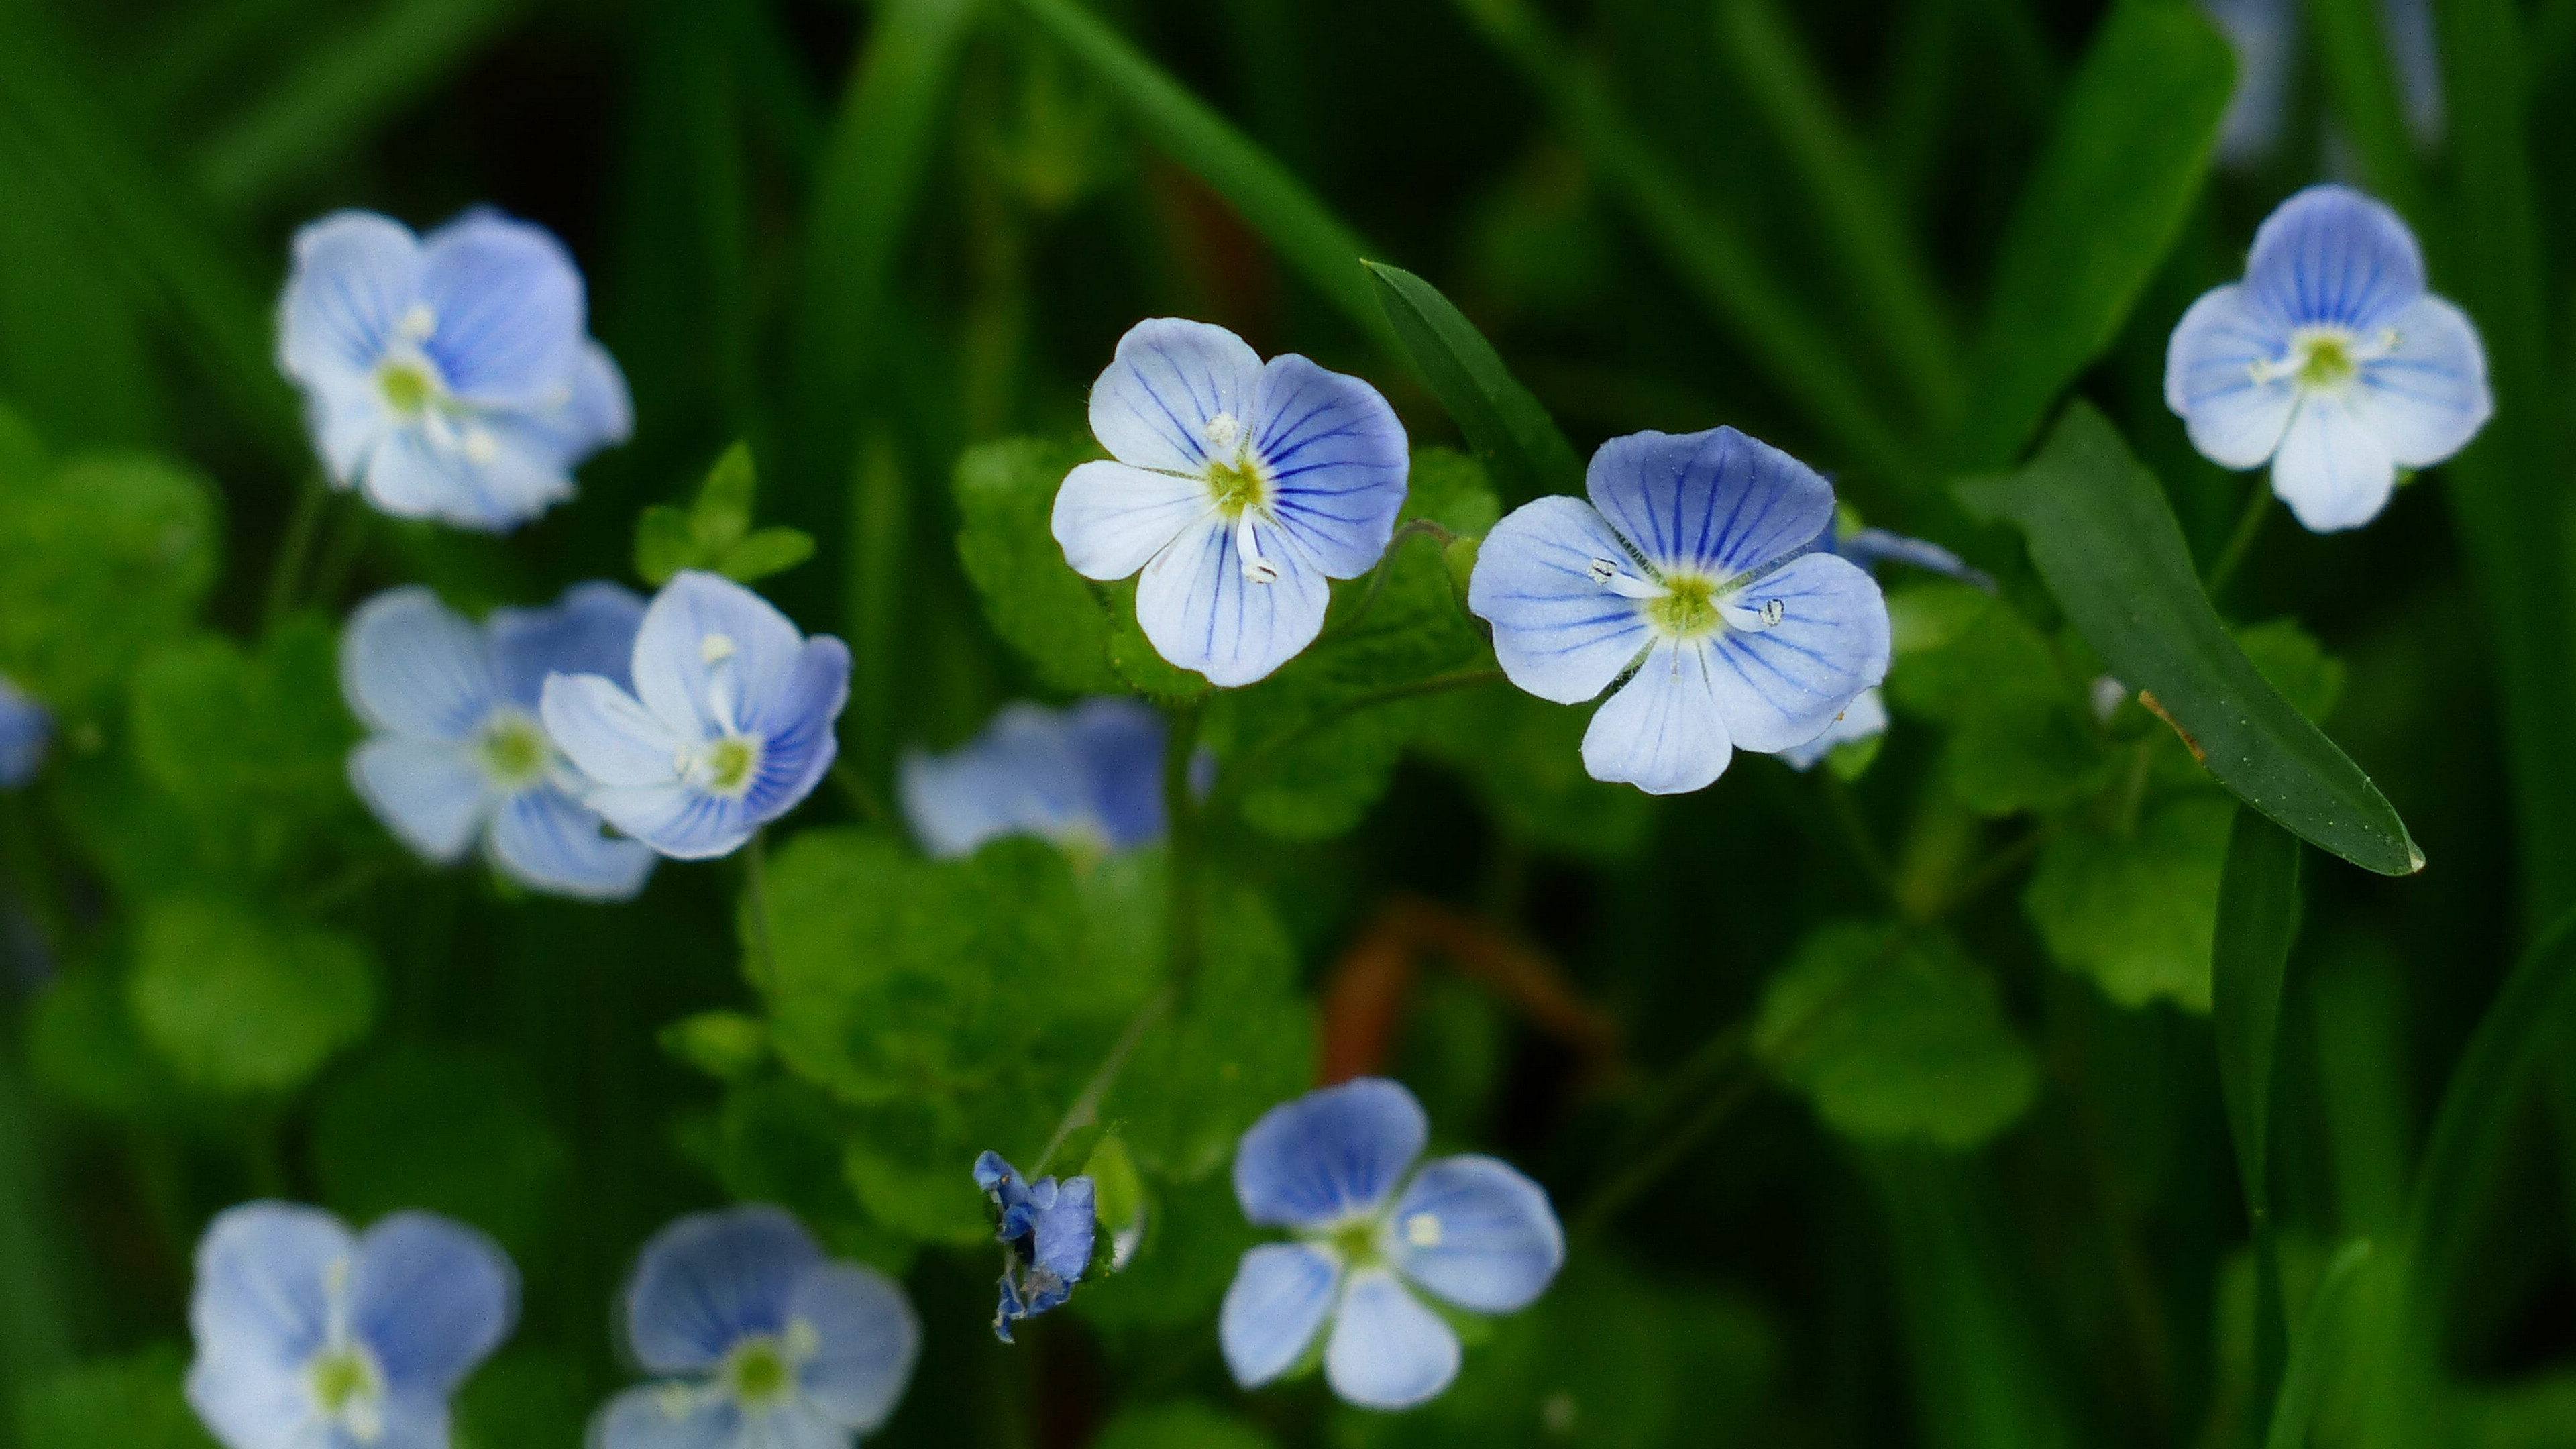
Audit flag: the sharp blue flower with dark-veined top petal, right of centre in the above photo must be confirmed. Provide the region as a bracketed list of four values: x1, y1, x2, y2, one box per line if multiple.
[1468, 428, 1888, 794]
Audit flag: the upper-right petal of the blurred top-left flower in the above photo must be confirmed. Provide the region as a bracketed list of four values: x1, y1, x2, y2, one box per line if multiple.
[420, 206, 588, 407]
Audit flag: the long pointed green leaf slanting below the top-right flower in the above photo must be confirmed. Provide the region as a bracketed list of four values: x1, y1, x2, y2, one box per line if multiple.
[1957, 402, 2424, 877]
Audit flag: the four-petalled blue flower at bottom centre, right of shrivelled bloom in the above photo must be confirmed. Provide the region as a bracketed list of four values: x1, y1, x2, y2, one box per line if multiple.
[1216, 1078, 1566, 1408]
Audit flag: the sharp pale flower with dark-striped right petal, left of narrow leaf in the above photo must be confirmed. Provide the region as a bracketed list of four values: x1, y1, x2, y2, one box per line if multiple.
[1054, 317, 1411, 686]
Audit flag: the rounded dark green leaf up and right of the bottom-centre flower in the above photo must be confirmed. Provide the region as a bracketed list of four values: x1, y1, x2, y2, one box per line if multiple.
[1752, 920, 2040, 1150]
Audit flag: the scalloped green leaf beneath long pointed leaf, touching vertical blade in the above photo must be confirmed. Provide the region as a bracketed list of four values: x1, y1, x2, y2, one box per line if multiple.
[2022, 789, 2229, 1011]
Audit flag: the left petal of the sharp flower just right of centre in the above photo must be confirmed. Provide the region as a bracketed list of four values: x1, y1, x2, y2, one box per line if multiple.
[1466, 498, 1651, 704]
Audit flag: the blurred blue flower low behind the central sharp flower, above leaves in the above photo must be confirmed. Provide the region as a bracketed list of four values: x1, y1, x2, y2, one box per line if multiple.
[896, 699, 1165, 859]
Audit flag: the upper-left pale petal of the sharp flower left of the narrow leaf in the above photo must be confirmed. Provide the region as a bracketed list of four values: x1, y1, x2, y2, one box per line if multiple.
[1087, 317, 1263, 474]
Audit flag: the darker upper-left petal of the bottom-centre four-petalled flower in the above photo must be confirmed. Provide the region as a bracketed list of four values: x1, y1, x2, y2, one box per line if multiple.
[1234, 1078, 1430, 1227]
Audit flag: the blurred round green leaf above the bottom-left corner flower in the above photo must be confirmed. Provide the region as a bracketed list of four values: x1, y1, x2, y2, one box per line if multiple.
[126, 895, 376, 1095]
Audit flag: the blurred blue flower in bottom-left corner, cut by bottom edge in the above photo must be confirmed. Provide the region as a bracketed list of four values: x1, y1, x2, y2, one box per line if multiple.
[188, 1201, 518, 1449]
